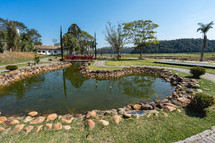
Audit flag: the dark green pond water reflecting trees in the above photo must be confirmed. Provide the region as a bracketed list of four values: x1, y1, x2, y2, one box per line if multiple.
[0, 66, 174, 115]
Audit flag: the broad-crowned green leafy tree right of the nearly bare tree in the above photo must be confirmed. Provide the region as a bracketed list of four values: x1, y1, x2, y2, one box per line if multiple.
[123, 20, 159, 59]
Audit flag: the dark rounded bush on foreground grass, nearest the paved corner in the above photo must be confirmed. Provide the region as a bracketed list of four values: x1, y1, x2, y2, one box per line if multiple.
[188, 93, 215, 113]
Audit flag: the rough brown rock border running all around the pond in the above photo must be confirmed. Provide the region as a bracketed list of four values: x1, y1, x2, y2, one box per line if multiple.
[0, 63, 202, 134]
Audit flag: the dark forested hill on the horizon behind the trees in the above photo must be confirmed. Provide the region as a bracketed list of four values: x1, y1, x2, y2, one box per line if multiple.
[97, 39, 215, 54]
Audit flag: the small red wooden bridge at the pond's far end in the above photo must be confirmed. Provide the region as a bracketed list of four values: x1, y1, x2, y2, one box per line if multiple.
[64, 55, 93, 62]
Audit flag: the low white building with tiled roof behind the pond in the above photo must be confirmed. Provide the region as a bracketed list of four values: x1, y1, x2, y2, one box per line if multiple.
[36, 45, 68, 55]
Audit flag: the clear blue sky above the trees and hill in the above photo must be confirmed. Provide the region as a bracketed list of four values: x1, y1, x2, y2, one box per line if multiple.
[0, 0, 215, 48]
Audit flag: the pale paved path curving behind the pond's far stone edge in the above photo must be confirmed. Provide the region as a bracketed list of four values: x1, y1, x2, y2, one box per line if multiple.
[94, 61, 215, 82]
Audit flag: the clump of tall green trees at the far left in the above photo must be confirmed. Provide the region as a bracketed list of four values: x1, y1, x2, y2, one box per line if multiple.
[0, 18, 42, 52]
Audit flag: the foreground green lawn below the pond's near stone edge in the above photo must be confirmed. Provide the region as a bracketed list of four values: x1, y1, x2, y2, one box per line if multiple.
[0, 110, 215, 143]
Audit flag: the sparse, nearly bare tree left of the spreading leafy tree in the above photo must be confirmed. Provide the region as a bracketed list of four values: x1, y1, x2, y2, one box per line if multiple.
[105, 22, 126, 60]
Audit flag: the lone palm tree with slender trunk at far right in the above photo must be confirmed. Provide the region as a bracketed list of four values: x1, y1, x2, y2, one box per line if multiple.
[197, 21, 214, 61]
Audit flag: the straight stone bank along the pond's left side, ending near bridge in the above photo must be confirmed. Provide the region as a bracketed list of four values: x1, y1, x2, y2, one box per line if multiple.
[0, 62, 72, 88]
